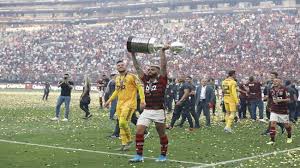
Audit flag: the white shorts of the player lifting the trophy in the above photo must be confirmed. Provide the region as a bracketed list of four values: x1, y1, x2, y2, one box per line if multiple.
[136, 109, 166, 127]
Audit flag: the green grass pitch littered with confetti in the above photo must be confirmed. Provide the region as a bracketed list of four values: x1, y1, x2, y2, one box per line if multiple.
[0, 90, 300, 168]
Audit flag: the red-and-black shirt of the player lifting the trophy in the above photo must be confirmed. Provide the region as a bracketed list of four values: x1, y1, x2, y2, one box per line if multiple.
[142, 75, 168, 110]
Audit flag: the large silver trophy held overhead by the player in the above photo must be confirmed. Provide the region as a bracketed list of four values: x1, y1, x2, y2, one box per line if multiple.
[127, 36, 185, 54]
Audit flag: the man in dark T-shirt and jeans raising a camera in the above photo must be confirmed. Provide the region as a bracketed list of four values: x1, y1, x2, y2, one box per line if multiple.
[51, 73, 74, 121]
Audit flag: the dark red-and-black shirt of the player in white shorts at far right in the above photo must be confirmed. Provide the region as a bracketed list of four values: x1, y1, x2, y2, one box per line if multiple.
[269, 86, 289, 114]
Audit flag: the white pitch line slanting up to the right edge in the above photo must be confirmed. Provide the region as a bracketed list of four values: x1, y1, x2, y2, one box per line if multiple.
[192, 147, 300, 168]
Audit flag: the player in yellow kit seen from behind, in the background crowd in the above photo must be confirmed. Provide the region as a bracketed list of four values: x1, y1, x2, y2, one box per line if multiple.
[222, 70, 239, 132]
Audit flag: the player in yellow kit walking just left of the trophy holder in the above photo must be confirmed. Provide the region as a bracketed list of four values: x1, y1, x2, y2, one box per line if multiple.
[105, 61, 146, 151]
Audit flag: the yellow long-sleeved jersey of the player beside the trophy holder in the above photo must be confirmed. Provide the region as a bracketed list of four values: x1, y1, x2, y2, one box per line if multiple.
[108, 73, 145, 109]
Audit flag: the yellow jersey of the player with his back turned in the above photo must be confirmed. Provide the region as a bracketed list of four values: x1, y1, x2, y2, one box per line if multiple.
[222, 77, 239, 104]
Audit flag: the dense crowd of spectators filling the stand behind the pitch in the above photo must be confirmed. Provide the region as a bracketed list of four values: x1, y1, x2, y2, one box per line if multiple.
[0, 11, 300, 82]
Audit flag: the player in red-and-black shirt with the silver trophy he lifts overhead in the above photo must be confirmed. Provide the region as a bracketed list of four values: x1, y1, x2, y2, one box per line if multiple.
[127, 37, 183, 162]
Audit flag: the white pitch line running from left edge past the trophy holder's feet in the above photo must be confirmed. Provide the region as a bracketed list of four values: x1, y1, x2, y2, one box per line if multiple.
[0, 139, 207, 165]
